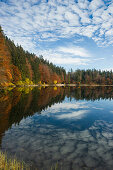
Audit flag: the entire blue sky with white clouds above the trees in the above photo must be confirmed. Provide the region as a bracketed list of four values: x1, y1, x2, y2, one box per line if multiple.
[0, 0, 113, 71]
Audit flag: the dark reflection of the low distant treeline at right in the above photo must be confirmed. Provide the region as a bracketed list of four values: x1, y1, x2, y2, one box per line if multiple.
[66, 86, 113, 101]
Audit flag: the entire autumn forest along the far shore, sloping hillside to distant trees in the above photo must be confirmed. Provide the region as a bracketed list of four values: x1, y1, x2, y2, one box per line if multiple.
[0, 26, 113, 86]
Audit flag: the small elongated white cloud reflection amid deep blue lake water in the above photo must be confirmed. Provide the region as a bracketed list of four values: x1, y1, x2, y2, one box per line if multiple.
[57, 110, 89, 119]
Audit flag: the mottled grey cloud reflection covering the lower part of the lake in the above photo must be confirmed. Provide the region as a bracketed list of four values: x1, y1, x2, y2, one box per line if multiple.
[2, 115, 113, 170]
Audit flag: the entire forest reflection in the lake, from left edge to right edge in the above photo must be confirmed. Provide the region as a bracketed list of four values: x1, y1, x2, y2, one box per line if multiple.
[0, 87, 113, 147]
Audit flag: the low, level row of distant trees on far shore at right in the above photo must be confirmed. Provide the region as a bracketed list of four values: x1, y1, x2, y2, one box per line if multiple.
[67, 69, 113, 85]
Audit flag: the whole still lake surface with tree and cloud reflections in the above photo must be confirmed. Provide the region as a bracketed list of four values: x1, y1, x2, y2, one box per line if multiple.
[0, 87, 113, 170]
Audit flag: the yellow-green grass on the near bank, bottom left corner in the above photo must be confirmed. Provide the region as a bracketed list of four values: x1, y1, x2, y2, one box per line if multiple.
[0, 151, 30, 170]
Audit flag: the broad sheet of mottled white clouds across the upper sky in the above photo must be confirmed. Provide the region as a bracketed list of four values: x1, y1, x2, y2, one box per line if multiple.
[0, 0, 113, 51]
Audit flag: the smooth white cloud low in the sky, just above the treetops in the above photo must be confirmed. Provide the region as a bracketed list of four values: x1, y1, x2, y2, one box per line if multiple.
[37, 46, 91, 65]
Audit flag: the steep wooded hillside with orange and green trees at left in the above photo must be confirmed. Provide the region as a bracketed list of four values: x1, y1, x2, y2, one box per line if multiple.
[0, 27, 66, 86]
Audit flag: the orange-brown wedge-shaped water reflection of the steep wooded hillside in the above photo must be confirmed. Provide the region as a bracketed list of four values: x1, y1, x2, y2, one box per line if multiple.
[0, 88, 65, 146]
